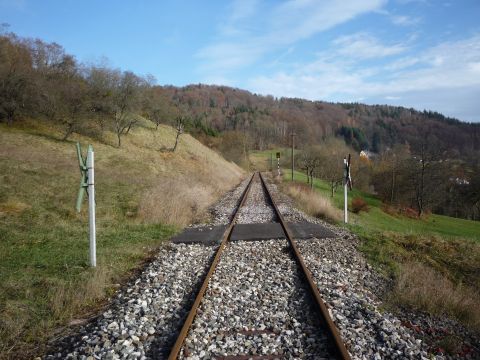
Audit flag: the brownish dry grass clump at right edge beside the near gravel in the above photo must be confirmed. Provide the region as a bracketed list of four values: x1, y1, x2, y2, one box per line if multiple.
[389, 262, 480, 331]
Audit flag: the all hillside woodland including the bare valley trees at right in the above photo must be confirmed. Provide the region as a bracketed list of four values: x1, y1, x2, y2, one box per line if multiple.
[0, 33, 480, 219]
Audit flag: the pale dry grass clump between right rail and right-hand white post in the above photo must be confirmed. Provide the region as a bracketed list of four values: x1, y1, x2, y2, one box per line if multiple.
[286, 184, 342, 223]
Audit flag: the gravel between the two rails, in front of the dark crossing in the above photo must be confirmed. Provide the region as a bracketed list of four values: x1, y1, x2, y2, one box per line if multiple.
[180, 240, 330, 359]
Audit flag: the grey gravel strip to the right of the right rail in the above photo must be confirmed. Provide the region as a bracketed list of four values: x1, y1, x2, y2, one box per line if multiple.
[269, 175, 480, 359]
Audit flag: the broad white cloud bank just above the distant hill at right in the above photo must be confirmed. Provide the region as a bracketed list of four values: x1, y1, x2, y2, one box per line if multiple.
[248, 35, 480, 120]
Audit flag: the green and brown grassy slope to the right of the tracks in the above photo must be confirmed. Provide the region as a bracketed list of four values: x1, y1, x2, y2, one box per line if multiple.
[278, 167, 480, 332]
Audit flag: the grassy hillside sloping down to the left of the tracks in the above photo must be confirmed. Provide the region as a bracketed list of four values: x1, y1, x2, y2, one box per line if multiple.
[0, 122, 243, 358]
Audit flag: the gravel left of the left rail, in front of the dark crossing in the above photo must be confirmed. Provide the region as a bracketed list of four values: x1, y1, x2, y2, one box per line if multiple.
[46, 244, 214, 360]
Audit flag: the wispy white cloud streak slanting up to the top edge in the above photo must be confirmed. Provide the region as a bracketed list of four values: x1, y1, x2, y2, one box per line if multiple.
[196, 0, 386, 76]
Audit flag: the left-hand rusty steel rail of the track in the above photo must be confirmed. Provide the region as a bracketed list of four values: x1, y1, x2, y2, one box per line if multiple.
[168, 173, 256, 360]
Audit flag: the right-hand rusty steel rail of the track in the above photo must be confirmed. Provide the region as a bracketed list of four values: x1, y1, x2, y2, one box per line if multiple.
[259, 173, 351, 360]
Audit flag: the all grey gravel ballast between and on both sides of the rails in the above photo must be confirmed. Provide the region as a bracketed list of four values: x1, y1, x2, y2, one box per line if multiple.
[44, 173, 479, 360]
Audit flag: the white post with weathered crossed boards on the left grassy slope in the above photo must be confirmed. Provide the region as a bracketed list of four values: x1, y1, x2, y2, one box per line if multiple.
[75, 143, 97, 267]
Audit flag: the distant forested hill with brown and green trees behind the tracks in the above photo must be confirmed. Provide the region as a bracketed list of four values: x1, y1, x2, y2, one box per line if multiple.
[162, 84, 480, 157]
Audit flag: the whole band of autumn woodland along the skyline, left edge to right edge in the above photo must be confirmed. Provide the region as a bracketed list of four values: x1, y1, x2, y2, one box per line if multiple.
[0, 29, 480, 160]
